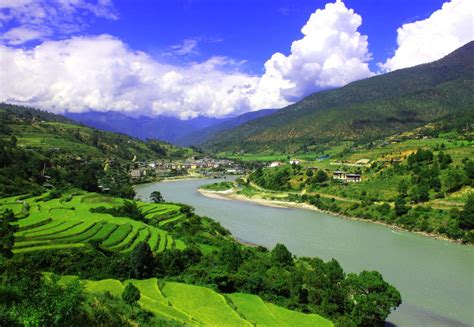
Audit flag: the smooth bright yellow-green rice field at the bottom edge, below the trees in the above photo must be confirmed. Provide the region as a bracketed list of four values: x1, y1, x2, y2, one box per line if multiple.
[72, 277, 333, 327]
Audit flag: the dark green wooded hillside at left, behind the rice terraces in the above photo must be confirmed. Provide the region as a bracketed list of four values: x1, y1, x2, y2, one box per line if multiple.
[0, 104, 193, 197]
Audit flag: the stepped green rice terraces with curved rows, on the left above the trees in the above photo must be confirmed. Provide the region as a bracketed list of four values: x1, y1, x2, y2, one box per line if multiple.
[0, 193, 186, 252]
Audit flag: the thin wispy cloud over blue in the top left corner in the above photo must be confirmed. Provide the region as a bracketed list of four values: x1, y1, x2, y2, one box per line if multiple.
[0, 0, 117, 45]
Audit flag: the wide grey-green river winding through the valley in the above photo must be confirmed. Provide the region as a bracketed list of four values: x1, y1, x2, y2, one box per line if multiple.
[136, 179, 474, 327]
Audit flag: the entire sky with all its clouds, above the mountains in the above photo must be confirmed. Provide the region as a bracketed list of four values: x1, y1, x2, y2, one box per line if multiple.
[0, 0, 474, 119]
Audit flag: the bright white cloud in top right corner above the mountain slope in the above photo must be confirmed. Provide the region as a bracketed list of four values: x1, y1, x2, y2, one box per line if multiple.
[379, 0, 474, 71]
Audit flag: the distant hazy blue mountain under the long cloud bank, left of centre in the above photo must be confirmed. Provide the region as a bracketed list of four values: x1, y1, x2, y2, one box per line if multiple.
[64, 111, 226, 144]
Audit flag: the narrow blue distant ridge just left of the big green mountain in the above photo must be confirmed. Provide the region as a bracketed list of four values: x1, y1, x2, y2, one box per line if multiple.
[176, 109, 278, 146]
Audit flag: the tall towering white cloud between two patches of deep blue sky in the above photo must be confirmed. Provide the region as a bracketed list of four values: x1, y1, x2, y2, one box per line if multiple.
[252, 0, 372, 107]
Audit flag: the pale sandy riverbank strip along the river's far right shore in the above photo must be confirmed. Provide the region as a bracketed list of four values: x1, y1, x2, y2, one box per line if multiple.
[197, 188, 466, 246]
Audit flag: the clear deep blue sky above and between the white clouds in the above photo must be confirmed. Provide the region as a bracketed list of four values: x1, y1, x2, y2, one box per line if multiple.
[89, 0, 444, 74]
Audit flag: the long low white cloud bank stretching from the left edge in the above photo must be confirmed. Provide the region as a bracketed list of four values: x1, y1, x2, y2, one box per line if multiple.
[0, 35, 258, 118]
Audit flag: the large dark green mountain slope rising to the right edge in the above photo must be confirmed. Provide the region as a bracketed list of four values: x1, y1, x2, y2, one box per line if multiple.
[204, 41, 474, 152]
